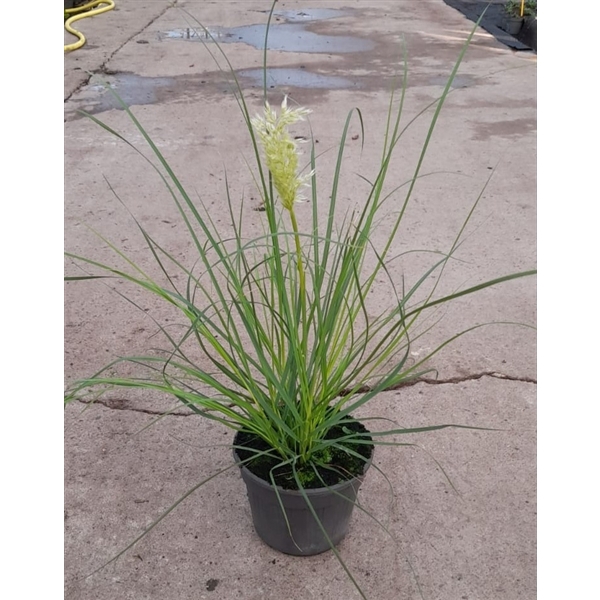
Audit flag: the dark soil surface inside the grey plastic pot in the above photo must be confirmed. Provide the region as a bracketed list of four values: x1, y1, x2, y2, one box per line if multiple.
[234, 419, 373, 490]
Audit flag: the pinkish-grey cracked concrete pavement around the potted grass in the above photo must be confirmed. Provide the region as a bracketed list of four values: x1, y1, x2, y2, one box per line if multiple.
[65, 0, 536, 600]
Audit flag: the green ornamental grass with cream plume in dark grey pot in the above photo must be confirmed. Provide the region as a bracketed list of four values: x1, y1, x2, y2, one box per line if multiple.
[65, 4, 535, 597]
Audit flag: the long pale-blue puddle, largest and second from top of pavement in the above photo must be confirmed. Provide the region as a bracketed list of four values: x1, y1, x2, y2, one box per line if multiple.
[158, 23, 375, 54]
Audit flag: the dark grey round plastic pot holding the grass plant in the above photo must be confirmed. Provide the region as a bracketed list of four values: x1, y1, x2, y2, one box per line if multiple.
[234, 434, 371, 556]
